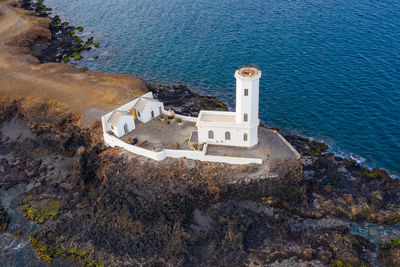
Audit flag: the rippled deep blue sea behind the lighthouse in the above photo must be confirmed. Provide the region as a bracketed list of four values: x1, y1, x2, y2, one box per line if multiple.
[45, 0, 400, 175]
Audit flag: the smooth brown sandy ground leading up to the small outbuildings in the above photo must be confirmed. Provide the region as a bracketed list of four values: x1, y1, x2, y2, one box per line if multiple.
[0, 1, 147, 119]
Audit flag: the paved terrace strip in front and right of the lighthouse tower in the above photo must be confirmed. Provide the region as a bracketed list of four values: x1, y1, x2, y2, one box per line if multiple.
[206, 127, 298, 162]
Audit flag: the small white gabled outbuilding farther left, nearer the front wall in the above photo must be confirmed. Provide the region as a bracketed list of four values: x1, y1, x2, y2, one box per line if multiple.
[107, 110, 135, 137]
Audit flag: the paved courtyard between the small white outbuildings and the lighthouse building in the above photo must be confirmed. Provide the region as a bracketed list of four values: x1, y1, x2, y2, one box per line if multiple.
[121, 118, 197, 151]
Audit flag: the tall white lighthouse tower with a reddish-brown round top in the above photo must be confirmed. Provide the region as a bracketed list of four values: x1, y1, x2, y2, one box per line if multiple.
[235, 67, 261, 146]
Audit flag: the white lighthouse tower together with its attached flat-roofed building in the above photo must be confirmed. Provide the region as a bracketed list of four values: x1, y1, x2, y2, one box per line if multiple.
[196, 67, 261, 147]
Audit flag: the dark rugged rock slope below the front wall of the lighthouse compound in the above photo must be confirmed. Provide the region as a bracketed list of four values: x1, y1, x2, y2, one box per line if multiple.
[0, 99, 400, 266]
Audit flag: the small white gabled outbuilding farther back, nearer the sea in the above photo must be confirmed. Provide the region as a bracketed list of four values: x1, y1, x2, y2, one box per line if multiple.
[133, 97, 164, 123]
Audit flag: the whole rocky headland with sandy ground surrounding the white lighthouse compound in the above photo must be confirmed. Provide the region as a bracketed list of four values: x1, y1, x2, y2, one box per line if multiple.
[0, 1, 400, 266]
